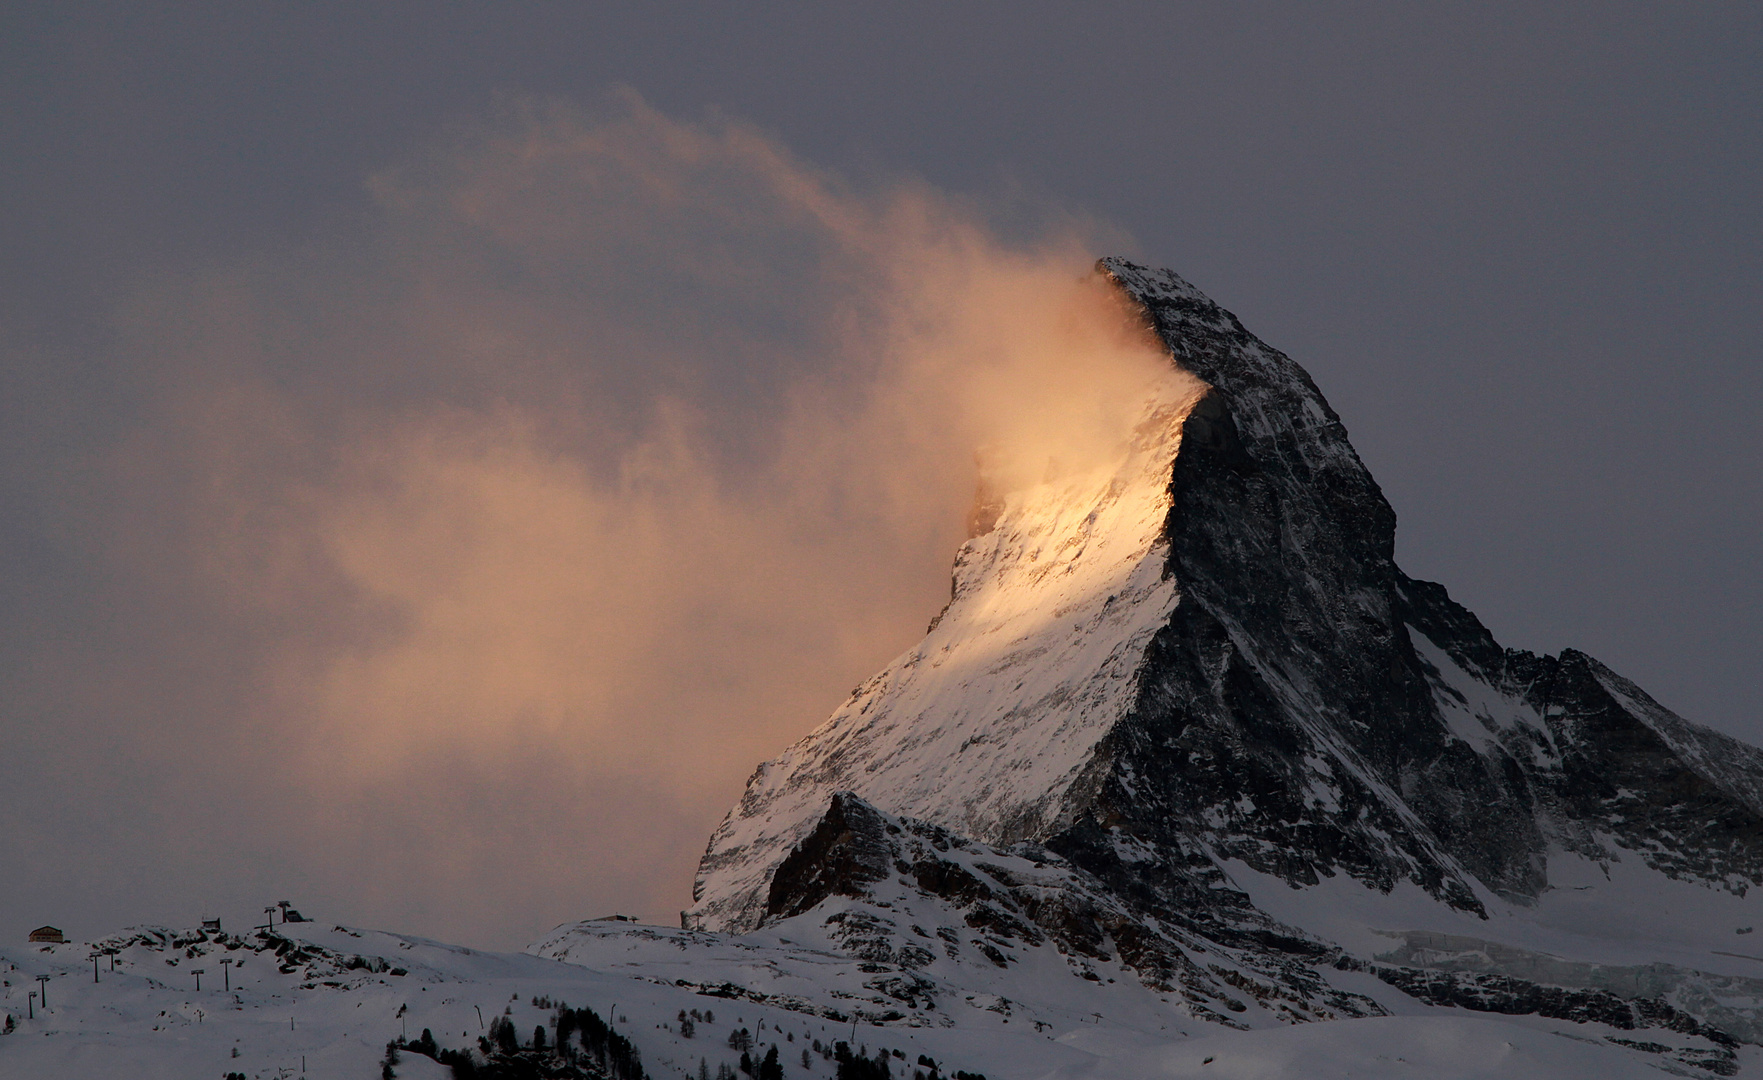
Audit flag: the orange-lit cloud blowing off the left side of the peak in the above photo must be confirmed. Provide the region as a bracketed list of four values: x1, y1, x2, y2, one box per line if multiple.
[51, 92, 1171, 921]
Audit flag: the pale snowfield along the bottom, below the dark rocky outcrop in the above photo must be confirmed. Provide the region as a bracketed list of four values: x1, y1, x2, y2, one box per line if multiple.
[0, 895, 1763, 1080]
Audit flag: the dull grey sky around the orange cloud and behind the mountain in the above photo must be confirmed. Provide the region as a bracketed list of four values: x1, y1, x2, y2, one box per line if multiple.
[0, 4, 1763, 944]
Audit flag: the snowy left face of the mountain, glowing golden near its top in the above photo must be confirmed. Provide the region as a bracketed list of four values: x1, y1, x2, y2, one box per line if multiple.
[686, 366, 1204, 930]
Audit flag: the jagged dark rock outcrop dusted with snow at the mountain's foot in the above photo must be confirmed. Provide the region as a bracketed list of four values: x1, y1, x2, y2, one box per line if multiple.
[765, 791, 1384, 1027]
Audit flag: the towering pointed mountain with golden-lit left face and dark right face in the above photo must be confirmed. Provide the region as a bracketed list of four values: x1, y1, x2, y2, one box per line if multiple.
[684, 259, 1763, 1064]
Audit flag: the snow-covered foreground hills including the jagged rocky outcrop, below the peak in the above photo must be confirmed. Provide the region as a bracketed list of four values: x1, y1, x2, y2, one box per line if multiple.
[0, 795, 1763, 1080]
